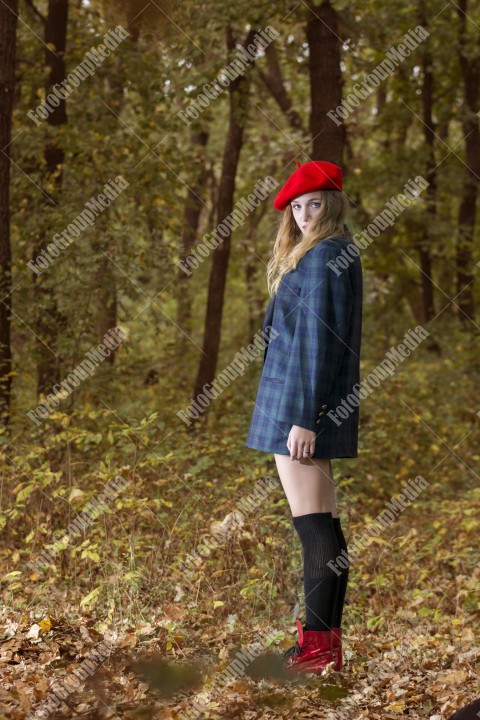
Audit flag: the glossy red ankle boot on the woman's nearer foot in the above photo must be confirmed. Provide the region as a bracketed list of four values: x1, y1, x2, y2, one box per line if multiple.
[283, 620, 337, 675]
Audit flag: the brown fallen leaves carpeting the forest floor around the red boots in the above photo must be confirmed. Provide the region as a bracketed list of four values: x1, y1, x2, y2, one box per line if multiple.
[0, 464, 480, 720]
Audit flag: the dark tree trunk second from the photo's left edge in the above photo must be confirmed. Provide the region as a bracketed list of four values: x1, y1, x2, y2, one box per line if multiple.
[34, 0, 68, 394]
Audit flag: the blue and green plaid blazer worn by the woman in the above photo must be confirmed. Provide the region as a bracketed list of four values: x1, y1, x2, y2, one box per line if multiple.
[246, 237, 363, 458]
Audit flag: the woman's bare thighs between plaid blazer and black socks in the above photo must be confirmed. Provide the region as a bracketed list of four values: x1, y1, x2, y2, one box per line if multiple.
[274, 454, 338, 517]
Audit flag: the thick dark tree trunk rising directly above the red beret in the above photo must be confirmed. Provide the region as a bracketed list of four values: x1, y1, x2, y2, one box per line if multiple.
[307, 0, 345, 165]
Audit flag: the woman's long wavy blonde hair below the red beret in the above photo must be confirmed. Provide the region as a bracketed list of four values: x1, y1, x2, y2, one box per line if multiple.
[267, 190, 350, 295]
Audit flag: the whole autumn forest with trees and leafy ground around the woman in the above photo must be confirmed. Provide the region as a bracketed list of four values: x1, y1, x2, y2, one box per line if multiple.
[0, 0, 480, 720]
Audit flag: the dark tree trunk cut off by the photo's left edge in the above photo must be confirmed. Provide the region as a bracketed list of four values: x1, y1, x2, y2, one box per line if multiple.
[0, 0, 18, 426]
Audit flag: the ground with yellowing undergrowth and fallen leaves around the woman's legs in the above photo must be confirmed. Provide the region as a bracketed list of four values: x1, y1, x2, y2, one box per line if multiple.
[0, 318, 480, 720]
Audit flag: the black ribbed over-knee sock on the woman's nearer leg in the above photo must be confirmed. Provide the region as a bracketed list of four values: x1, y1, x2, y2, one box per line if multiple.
[293, 512, 340, 630]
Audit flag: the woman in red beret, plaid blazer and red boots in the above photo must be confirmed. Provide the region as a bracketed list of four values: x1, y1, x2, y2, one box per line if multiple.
[246, 161, 362, 673]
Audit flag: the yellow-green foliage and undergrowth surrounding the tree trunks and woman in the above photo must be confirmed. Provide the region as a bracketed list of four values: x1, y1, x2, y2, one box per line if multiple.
[0, 0, 480, 716]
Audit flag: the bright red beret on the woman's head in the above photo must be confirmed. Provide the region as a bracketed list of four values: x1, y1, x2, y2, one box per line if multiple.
[273, 160, 342, 210]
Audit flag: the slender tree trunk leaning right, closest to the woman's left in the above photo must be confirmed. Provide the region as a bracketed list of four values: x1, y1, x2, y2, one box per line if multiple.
[194, 28, 255, 424]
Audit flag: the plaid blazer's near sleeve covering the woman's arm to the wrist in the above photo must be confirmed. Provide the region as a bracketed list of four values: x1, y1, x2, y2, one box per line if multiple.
[277, 240, 353, 432]
